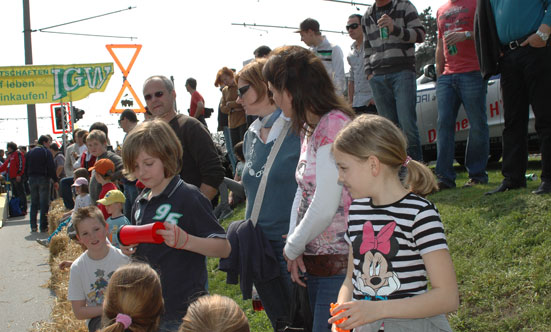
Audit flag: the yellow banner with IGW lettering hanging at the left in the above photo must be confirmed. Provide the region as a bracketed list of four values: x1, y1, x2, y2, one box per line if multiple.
[0, 63, 113, 105]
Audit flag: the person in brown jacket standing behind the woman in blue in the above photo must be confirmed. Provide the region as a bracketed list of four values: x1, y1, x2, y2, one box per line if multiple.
[220, 67, 247, 162]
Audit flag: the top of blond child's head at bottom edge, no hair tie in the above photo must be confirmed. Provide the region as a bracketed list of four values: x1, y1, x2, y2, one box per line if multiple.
[178, 294, 250, 332]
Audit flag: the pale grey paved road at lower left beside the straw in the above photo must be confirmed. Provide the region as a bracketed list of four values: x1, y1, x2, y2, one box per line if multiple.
[0, 216, 54, 332]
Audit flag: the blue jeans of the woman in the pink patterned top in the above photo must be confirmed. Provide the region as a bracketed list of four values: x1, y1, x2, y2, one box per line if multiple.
[306, 274, 346, 332]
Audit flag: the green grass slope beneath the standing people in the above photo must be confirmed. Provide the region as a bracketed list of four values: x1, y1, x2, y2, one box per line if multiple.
[209, 160, 551, 332]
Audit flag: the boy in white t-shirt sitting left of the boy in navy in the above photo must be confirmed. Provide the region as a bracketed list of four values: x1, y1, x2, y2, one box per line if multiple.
[67, 206, 129, 332]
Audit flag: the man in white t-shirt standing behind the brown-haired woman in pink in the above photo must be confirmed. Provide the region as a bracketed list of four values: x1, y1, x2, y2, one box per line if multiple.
[295, 18, 345, 96]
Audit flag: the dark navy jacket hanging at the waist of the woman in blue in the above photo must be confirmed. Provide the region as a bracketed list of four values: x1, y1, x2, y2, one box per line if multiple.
[219, 219, 280, 300]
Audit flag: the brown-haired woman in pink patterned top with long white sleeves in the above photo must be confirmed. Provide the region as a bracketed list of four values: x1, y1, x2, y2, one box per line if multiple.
[263, 46, 354, 332]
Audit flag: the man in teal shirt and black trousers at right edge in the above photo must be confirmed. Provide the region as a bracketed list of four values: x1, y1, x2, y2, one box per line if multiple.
[484, 0, 551, 195]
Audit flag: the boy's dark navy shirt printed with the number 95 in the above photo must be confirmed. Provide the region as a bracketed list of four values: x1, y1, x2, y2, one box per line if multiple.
[132, 176, 226, 321]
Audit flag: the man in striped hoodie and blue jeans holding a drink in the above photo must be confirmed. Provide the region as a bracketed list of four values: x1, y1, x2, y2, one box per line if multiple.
[362, 0, 425, 161]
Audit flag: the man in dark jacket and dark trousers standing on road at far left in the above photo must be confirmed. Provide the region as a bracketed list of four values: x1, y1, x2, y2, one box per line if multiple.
[25, 135, 58, 233]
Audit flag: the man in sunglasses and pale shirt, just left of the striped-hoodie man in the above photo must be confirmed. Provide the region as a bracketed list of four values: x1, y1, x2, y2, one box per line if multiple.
[346, 14, 377, 115]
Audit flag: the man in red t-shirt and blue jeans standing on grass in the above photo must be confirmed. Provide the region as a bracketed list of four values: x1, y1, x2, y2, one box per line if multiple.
[436, 0, 490, 190]
